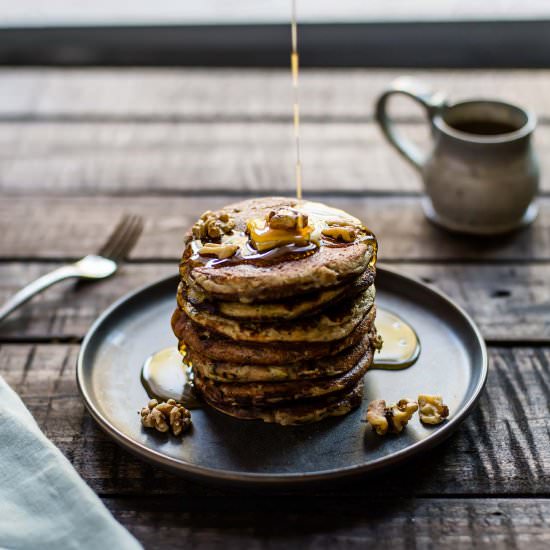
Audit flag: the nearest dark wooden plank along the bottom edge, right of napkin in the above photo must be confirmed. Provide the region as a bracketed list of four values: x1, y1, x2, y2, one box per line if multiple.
[105, 495, 550, 550]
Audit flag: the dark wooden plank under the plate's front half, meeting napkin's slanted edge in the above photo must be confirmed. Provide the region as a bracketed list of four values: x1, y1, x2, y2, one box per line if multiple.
[0, 344, 550, 500]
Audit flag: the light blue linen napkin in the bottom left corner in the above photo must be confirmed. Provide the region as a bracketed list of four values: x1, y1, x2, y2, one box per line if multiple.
[0, 377, 141, 550]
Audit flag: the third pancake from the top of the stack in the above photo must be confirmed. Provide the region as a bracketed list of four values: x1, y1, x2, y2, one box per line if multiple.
[181, 285, 375, 343]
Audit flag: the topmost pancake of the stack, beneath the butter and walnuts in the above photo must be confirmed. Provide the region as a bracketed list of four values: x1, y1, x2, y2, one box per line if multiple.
[180, 197, 376, 303]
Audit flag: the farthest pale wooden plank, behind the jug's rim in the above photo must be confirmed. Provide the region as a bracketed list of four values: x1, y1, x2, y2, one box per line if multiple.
[0, 68, 550, 121]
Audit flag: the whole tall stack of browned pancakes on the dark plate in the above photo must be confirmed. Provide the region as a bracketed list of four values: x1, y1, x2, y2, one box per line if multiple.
[172, 198, 376, 424]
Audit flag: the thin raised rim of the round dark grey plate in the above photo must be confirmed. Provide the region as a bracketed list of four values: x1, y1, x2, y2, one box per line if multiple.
[76, 267, 489, 486]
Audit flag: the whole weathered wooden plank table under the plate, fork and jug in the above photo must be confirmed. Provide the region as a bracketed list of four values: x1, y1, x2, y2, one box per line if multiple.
[0, 69, 550, 549]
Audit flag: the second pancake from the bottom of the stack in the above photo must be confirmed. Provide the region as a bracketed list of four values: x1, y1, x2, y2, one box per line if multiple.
[193, 347, 373, 406]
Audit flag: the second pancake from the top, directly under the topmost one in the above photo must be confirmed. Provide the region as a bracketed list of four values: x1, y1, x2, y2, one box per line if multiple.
[177, 268, 375, 321]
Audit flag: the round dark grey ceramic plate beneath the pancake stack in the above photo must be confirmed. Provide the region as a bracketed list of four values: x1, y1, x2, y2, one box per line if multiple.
[77, 269, 487, 485]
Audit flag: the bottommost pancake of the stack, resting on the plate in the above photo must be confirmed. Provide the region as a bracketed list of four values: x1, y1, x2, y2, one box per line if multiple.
[205, 382, 363, 426]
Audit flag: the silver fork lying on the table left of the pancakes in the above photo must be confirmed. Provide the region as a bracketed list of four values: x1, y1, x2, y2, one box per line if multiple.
[0, 214, 143, 322]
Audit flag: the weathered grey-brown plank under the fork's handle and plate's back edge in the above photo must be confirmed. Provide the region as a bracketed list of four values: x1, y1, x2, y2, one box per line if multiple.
[0, 261, 550, 342]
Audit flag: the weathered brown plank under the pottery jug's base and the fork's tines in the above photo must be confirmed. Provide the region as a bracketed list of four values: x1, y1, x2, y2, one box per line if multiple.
[0, 195, 550, 261]
